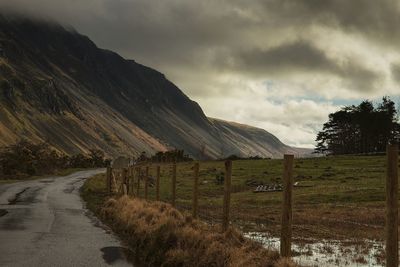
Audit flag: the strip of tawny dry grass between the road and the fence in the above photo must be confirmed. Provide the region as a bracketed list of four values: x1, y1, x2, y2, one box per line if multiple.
[100, 196, 297, 267]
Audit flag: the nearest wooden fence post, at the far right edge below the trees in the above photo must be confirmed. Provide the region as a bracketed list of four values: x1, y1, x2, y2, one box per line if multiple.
[386, 144, 399, 267]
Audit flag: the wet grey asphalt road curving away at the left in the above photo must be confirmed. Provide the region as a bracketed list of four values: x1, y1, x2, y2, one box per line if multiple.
[0, 170, 132, 266]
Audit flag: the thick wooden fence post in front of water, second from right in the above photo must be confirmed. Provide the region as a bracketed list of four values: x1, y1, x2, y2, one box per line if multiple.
[280, 155, 294, 257]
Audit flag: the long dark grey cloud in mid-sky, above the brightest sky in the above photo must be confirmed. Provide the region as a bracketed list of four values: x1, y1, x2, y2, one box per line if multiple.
[219, 40, 381, 91]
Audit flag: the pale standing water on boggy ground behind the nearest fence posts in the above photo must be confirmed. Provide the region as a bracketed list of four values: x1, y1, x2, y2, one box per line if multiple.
[245, 232, 385, 267]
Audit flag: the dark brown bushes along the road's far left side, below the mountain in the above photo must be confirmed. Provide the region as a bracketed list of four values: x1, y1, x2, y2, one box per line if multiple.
[0, 141, 110, 177]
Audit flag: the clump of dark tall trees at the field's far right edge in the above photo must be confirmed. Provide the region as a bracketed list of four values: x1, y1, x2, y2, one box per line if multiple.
[315, 97, 400, 155]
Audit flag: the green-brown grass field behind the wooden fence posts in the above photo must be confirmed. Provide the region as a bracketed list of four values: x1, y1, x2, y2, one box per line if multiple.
[116, 156, 396, 243]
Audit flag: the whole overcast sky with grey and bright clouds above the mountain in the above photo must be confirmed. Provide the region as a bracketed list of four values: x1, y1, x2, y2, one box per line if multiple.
[0, 0, 400, 147]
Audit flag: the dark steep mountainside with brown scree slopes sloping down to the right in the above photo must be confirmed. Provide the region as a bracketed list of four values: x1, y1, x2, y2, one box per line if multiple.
[0, 15, 309, 158]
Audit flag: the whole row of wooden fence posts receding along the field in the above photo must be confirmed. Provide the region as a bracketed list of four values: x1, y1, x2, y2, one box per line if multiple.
[106, 147, 399, 267]
